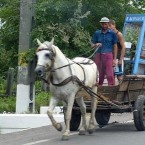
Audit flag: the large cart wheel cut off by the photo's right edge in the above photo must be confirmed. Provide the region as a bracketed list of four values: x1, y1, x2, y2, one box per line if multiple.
[133, 95, 145, 131]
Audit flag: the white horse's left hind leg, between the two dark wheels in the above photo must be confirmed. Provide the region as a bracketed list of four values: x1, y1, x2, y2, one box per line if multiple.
[76, 97, 87, 135]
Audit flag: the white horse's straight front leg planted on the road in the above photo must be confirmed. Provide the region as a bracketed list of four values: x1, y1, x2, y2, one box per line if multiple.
[62, 95, 74, 140]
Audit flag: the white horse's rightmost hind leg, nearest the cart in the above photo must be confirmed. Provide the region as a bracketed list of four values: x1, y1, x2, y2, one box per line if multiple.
[88, 87, 97, 134]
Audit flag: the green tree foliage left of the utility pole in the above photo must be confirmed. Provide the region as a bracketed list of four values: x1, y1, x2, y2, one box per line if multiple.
[0, 0, 20, 75]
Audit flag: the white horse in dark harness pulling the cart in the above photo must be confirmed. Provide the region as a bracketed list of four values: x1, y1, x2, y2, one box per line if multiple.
[35, 39, 97, 140]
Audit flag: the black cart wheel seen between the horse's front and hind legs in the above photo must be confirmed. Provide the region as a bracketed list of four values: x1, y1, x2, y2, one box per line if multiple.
[64, 110, 81, 131]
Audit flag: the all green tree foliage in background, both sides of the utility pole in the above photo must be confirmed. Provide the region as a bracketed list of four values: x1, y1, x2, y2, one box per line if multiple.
[0, 0, 145, 75]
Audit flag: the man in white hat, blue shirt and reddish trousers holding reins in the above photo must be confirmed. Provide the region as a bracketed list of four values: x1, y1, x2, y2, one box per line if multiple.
[92, 17, 117, 86]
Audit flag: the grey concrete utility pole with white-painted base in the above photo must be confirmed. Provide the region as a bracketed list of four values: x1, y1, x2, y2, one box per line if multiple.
[16, 0, 36, 113]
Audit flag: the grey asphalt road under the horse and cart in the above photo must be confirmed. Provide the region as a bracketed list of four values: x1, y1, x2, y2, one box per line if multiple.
[0, 113, 145, 145]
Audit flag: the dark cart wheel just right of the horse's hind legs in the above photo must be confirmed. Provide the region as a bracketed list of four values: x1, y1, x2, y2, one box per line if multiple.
[95, 111, 111, 127]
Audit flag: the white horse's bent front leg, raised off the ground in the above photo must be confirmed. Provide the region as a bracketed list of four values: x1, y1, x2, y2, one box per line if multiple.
[47, 97, 62, 131]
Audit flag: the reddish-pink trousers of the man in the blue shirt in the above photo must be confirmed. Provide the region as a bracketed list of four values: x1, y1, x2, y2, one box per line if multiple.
[95, 52, 115, 86]
